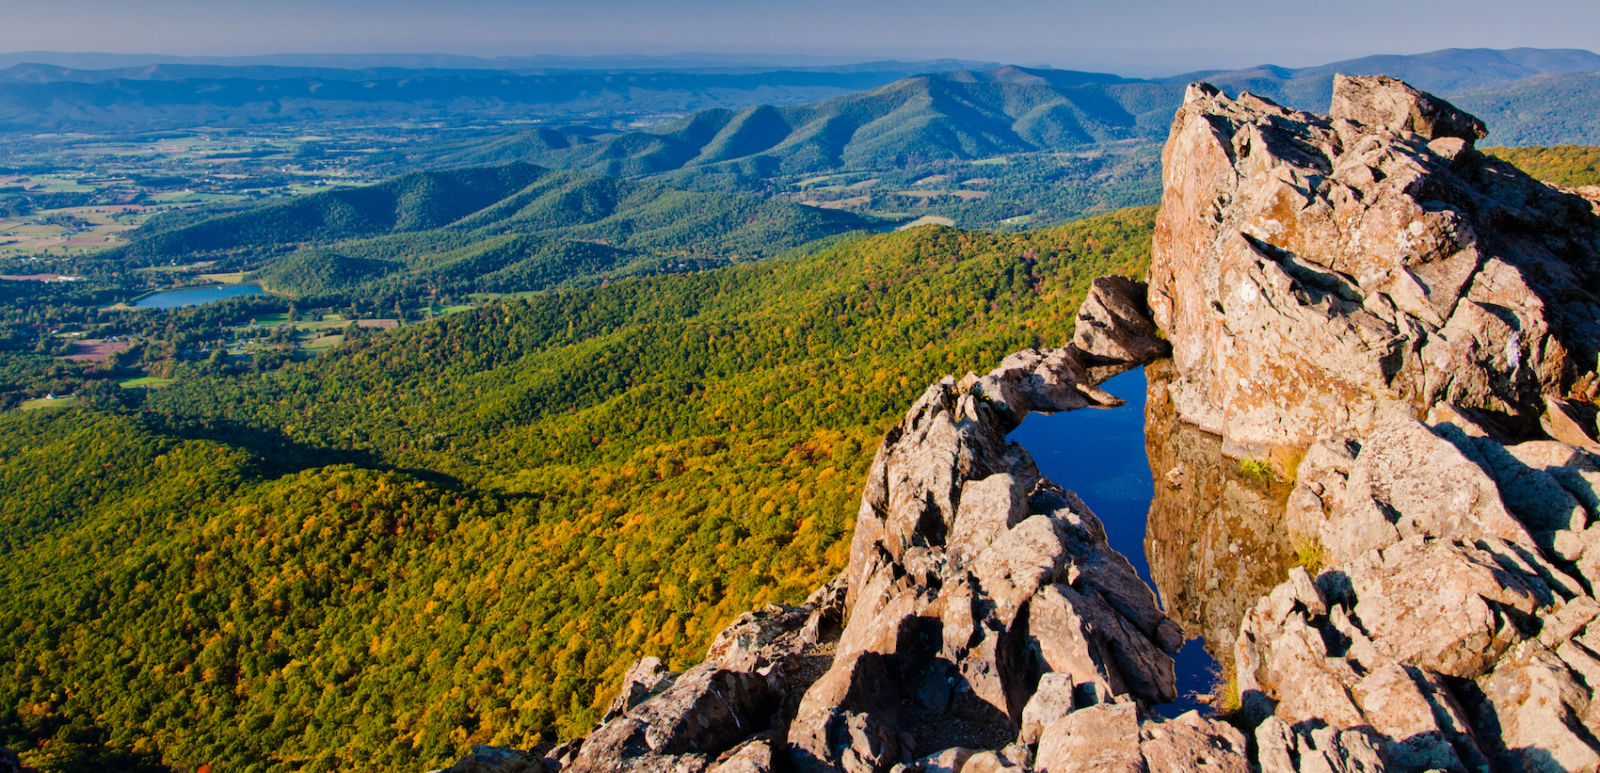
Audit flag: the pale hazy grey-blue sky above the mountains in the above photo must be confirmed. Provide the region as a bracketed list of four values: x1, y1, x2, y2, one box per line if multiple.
[0, 0, 1600, 75]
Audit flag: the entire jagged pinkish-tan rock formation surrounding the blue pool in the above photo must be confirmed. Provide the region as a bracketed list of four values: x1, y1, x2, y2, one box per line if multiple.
[438, 77, 1600, 773]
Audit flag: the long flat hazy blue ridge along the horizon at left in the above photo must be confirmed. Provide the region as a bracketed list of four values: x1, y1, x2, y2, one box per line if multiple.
[0, 61, 998, 133]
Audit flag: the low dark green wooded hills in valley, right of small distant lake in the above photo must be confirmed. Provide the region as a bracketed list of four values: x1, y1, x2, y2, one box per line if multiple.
[98, 162, 867, 306]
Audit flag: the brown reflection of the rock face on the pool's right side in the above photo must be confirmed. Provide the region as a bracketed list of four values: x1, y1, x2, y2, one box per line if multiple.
[1144, 360, 1294, 663]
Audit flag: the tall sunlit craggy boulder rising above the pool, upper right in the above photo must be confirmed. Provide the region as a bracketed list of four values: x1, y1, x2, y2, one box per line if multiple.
[1150, 77, 1600, 477]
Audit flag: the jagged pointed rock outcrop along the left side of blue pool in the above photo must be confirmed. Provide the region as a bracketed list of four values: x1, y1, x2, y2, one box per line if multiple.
[789, 347, 1182, 770]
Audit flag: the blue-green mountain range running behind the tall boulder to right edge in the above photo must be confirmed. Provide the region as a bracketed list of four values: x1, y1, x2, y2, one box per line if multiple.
[461, 50, 1600, 184]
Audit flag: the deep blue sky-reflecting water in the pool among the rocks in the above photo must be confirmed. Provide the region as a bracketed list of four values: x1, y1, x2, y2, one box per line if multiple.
[1010, 368, 1216, 717]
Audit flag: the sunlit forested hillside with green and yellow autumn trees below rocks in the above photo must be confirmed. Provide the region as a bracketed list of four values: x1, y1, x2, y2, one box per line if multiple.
[0, 210, 1154, 770]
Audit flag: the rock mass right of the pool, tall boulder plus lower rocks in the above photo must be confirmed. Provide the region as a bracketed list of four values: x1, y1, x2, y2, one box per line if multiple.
[1150, 78, 1600, 771]
